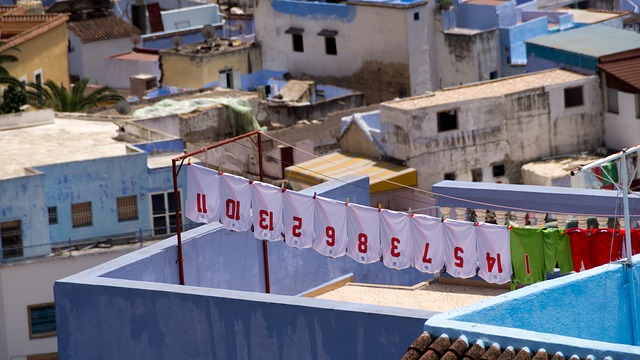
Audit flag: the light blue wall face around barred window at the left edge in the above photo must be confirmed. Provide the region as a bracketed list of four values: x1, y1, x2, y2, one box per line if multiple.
[0, 173, 51, 260]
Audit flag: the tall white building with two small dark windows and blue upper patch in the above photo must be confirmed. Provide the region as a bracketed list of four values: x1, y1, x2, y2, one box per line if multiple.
[255, 0, 437, 103]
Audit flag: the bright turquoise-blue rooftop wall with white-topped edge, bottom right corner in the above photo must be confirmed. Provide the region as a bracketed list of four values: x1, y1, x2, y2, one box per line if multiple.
[425, 256, 640, 359]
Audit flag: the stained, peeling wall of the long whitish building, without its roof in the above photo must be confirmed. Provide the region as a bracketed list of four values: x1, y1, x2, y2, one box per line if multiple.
[380, 76, 603, 188]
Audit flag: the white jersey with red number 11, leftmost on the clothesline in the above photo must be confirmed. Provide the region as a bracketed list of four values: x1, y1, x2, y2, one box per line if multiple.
[184, 164, 220, 224]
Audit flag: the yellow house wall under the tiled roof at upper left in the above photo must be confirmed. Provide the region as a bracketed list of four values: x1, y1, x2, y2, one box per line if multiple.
[3, 23, 69, 89]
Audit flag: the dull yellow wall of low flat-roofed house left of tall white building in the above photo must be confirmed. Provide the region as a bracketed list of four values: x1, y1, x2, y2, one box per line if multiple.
[160, 45, 262, 89]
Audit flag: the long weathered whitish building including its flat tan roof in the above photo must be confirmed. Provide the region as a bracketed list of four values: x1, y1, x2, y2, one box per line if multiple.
[380, 70, 603, 188]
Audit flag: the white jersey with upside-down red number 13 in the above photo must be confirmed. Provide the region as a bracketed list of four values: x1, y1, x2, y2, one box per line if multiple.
[251, 181, 282, 241]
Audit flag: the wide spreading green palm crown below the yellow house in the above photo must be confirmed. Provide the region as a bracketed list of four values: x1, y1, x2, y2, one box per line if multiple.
[27, 79, 124, 112]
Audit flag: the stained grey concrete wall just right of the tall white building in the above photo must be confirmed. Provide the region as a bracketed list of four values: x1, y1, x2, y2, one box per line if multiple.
[438, 29, 502, 88]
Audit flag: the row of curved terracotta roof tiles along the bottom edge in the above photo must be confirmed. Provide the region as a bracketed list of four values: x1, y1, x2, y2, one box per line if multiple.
[402, 332, 604, 360]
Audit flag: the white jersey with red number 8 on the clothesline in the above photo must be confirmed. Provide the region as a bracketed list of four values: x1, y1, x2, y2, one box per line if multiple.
[347, 204, 382, 264]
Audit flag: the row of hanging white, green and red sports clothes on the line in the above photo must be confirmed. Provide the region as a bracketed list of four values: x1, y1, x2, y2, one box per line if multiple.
[185, 164, 640, 284]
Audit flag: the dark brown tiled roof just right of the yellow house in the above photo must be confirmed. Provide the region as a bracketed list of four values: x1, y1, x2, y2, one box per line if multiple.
[67, 13, 141, 44]
